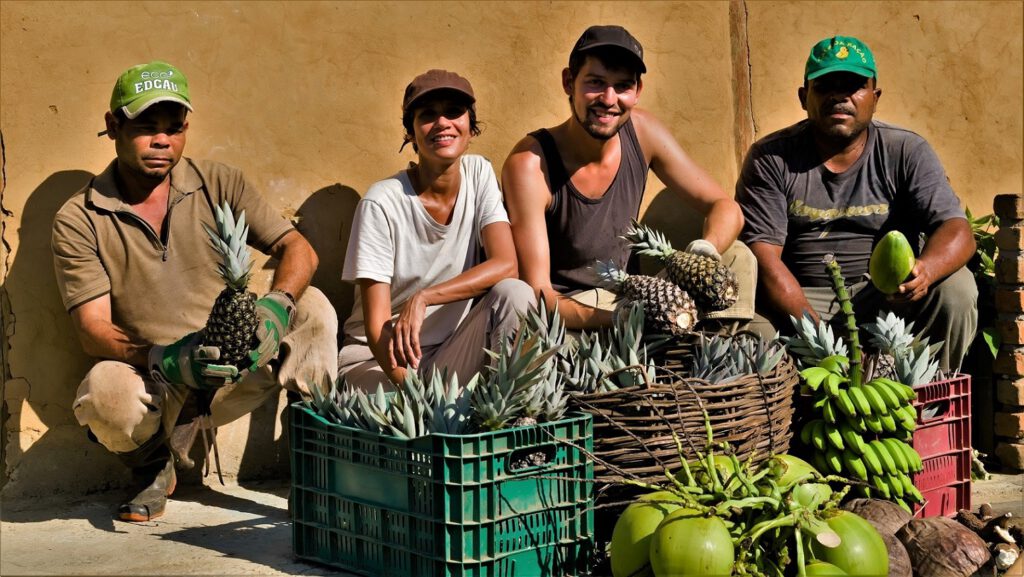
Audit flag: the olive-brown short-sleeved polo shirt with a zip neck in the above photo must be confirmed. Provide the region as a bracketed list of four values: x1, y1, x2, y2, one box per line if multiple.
[51, 158, 293, 344]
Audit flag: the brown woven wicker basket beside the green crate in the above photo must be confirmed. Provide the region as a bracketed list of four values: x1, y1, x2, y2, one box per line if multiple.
[573, 351, 799, 483]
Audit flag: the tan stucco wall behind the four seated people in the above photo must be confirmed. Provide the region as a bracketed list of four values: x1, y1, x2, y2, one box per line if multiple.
[0, 1, 1022, 495]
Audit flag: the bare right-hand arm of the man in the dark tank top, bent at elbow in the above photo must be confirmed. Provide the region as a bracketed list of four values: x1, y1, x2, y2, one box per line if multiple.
[633, 109, 743, 253]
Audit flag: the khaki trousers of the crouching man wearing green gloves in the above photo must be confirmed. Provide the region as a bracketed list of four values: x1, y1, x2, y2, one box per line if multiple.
[74, 287, 338, 453]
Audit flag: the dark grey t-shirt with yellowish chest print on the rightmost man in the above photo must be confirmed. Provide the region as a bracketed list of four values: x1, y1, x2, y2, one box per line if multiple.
[736, 120, 965, 287]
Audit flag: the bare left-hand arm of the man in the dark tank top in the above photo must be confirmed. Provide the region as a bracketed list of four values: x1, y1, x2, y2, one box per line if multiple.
[502, 137, 612, 330]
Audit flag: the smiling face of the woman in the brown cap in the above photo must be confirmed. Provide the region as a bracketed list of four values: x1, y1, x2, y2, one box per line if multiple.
[412, 94, 476, 162]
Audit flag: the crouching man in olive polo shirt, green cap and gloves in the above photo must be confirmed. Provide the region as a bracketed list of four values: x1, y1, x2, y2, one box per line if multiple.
[52, 61, 337, 522]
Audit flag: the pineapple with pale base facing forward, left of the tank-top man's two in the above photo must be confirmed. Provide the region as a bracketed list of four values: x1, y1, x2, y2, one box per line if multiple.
[594, 261, 697, 336]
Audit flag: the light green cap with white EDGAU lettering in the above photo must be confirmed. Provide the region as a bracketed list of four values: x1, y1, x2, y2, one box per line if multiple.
[111, 60, 193, 119]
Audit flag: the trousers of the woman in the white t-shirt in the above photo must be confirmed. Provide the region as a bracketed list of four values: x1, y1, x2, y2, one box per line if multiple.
[338, 279, 537, 393]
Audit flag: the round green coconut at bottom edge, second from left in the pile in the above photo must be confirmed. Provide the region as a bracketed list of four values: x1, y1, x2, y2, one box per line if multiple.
[650, 508, 736, 577]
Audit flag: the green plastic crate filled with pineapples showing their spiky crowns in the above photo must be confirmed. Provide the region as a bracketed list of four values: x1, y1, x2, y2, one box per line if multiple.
[291, 303, 594, 577]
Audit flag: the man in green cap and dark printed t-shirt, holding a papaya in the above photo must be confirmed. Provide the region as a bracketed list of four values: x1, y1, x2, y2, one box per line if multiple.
[736, 36, 978, 369]
